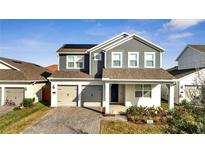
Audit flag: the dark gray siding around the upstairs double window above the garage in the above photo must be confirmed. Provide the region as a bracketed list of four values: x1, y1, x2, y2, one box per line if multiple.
[59, 54, 89, 72]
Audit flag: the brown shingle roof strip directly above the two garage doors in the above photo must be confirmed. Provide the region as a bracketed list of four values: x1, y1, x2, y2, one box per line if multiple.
[50, 71, 102, 79]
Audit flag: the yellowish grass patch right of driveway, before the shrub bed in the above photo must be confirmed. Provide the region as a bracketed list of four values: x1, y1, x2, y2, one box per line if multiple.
[100, 120, 166, 134]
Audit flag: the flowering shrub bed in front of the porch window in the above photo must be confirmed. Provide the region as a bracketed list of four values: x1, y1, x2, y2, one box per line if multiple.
[127, 106, 167, 124]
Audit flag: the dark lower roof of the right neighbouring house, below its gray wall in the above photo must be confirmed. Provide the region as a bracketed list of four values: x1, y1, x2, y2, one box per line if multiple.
[167, 66, 203, 79]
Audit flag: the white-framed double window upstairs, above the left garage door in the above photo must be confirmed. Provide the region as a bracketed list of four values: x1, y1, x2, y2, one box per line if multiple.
[67, 55, 84, 69]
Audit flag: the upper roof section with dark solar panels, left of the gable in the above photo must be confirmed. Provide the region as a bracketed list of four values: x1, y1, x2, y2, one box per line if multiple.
[57, 44, 97, 52]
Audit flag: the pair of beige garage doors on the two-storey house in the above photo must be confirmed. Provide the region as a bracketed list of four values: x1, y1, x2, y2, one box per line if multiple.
[57, 85, 103, 107]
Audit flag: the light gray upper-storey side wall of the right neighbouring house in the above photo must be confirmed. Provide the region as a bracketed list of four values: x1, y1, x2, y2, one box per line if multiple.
[178, 47, 205, 69]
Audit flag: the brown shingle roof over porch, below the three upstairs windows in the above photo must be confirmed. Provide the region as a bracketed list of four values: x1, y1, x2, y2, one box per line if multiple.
[103, 68, 174, 80]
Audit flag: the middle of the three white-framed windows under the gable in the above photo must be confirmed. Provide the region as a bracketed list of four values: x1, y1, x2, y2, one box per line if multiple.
[128, 52, 139, 67]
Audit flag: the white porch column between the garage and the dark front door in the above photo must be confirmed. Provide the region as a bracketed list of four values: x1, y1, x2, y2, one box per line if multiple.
[103, 83, 110, 114]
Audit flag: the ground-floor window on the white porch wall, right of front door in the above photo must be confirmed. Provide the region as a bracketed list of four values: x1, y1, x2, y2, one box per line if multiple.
[135, 84, 152, 97]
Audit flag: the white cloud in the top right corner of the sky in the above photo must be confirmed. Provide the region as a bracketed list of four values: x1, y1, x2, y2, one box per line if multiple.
[163, 19, 205, 30]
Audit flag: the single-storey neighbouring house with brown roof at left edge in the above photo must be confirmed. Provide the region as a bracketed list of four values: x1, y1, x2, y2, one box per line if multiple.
[0, 57, 50, 105]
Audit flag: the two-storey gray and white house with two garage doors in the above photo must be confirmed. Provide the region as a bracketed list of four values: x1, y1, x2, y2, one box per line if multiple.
[48, 33, 175, 113]
